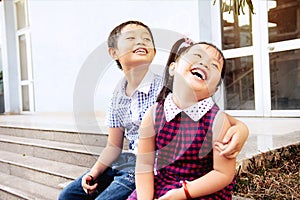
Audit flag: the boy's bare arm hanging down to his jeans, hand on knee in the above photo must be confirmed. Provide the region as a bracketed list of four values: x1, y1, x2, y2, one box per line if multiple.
[81, 128, 124, 193]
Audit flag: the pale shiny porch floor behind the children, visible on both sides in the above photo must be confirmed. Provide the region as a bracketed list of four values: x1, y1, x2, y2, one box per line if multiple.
[0, 113, 300, 160]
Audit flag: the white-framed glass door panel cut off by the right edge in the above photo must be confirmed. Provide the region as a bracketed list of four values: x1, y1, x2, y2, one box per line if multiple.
[267, 0, 300, 111]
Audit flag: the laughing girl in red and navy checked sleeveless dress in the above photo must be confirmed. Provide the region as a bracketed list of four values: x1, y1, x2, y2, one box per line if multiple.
[129, 39, 236, 200]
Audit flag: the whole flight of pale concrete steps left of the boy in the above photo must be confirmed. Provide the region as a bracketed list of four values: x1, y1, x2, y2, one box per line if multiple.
[0, 126, 107, 200]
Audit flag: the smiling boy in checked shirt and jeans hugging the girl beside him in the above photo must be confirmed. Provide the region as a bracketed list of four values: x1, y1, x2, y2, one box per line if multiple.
[59, 21, 248, 200]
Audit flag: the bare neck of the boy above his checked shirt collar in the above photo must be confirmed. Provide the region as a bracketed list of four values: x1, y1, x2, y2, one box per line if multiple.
[124, 66, 149, 96]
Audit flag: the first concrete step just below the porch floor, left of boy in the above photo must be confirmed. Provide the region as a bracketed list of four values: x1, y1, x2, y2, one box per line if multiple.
[0, 135, 103, 167]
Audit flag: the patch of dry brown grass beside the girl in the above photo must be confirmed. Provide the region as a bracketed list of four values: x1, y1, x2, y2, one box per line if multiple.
[234, 143, 300, 200]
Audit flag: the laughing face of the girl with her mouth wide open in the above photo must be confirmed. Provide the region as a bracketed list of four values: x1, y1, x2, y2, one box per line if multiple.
[170, 44, 224, 99]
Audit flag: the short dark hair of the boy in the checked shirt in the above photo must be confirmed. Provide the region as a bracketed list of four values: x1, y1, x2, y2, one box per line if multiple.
[107, 21, 155, 70]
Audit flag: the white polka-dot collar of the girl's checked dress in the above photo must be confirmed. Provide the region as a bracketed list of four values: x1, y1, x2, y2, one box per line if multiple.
[164, 94, 214, 122]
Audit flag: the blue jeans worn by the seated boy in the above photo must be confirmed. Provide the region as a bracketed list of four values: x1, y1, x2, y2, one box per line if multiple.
[58, 153, 136, 200]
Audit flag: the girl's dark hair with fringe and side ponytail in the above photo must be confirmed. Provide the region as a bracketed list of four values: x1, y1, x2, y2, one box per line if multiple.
[156, 38, 226, 102]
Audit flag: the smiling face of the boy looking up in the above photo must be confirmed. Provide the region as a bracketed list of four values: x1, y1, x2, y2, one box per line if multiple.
[114, 24, 156, 70]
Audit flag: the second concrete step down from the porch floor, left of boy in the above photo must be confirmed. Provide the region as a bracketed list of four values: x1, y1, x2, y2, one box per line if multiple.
[0, 151, 88, 189]
